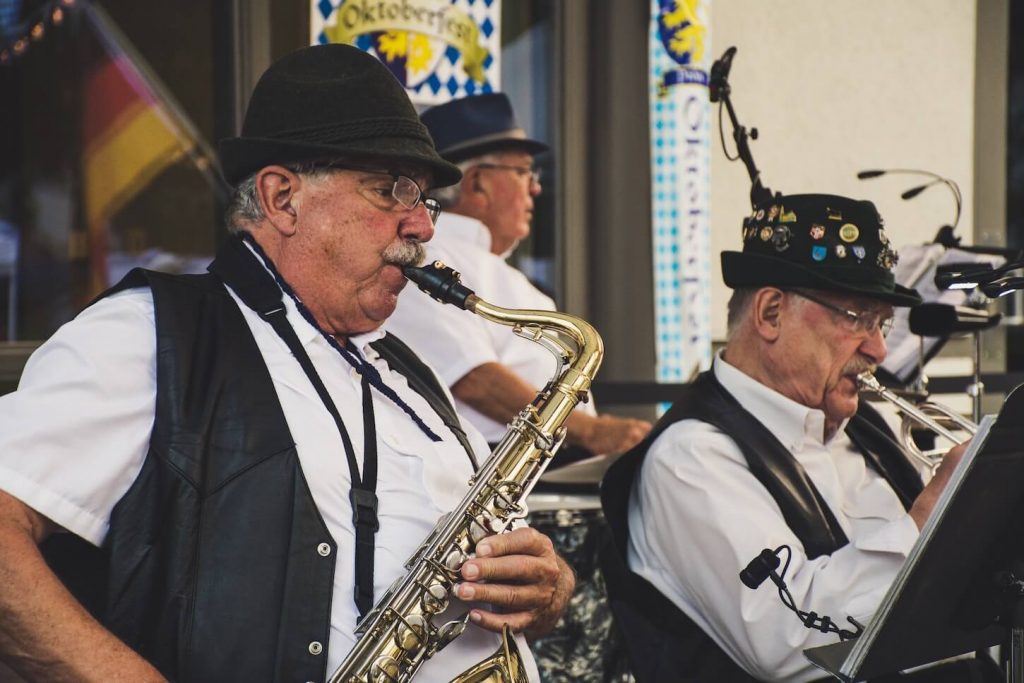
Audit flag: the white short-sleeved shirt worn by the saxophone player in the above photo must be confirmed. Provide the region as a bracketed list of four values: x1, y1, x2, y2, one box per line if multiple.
[0, 253, 539, 682]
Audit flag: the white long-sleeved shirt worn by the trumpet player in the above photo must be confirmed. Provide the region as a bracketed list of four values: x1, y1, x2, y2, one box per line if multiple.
[628, 355, 918, 681]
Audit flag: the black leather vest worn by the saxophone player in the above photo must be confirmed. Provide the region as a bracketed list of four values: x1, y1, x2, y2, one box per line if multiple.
[39, 253, 467, 683]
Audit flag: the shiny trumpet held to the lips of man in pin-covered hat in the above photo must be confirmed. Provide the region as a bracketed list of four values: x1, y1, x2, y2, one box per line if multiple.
[857, 371, 978, 474]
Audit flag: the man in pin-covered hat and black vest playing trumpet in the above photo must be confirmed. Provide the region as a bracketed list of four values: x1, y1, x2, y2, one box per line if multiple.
[603, 195, 995, 682]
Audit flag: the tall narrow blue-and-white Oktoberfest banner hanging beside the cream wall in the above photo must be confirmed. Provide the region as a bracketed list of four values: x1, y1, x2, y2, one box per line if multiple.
[648, 0, 712, 382]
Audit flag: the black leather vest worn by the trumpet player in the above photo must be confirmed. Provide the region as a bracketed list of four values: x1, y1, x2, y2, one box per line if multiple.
[601, 372, 922, 683]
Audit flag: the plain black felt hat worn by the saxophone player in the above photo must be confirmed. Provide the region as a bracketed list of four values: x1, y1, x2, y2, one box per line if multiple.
[218, 44, 462, 186]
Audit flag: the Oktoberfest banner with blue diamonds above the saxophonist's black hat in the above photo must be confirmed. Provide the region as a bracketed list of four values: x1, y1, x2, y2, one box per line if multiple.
[309, 0, 502, 104]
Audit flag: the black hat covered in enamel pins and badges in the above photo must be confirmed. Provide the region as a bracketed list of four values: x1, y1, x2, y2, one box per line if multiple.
[722, 195, 921, 306]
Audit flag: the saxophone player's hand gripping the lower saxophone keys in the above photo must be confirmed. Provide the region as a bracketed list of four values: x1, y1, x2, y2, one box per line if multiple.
[456, 527, 575, 638]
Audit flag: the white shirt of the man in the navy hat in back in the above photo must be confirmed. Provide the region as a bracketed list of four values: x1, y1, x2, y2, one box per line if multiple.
[388, 213, 594, 443]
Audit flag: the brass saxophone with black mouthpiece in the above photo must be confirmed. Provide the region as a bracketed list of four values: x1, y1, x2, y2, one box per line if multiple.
[328, 261, 604, 683]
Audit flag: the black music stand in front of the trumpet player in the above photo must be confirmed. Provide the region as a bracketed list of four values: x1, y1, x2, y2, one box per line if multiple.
[804, 387, 1024, 683]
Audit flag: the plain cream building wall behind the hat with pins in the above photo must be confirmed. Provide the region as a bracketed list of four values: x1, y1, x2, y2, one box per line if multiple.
[712, 0, 974, 339]
